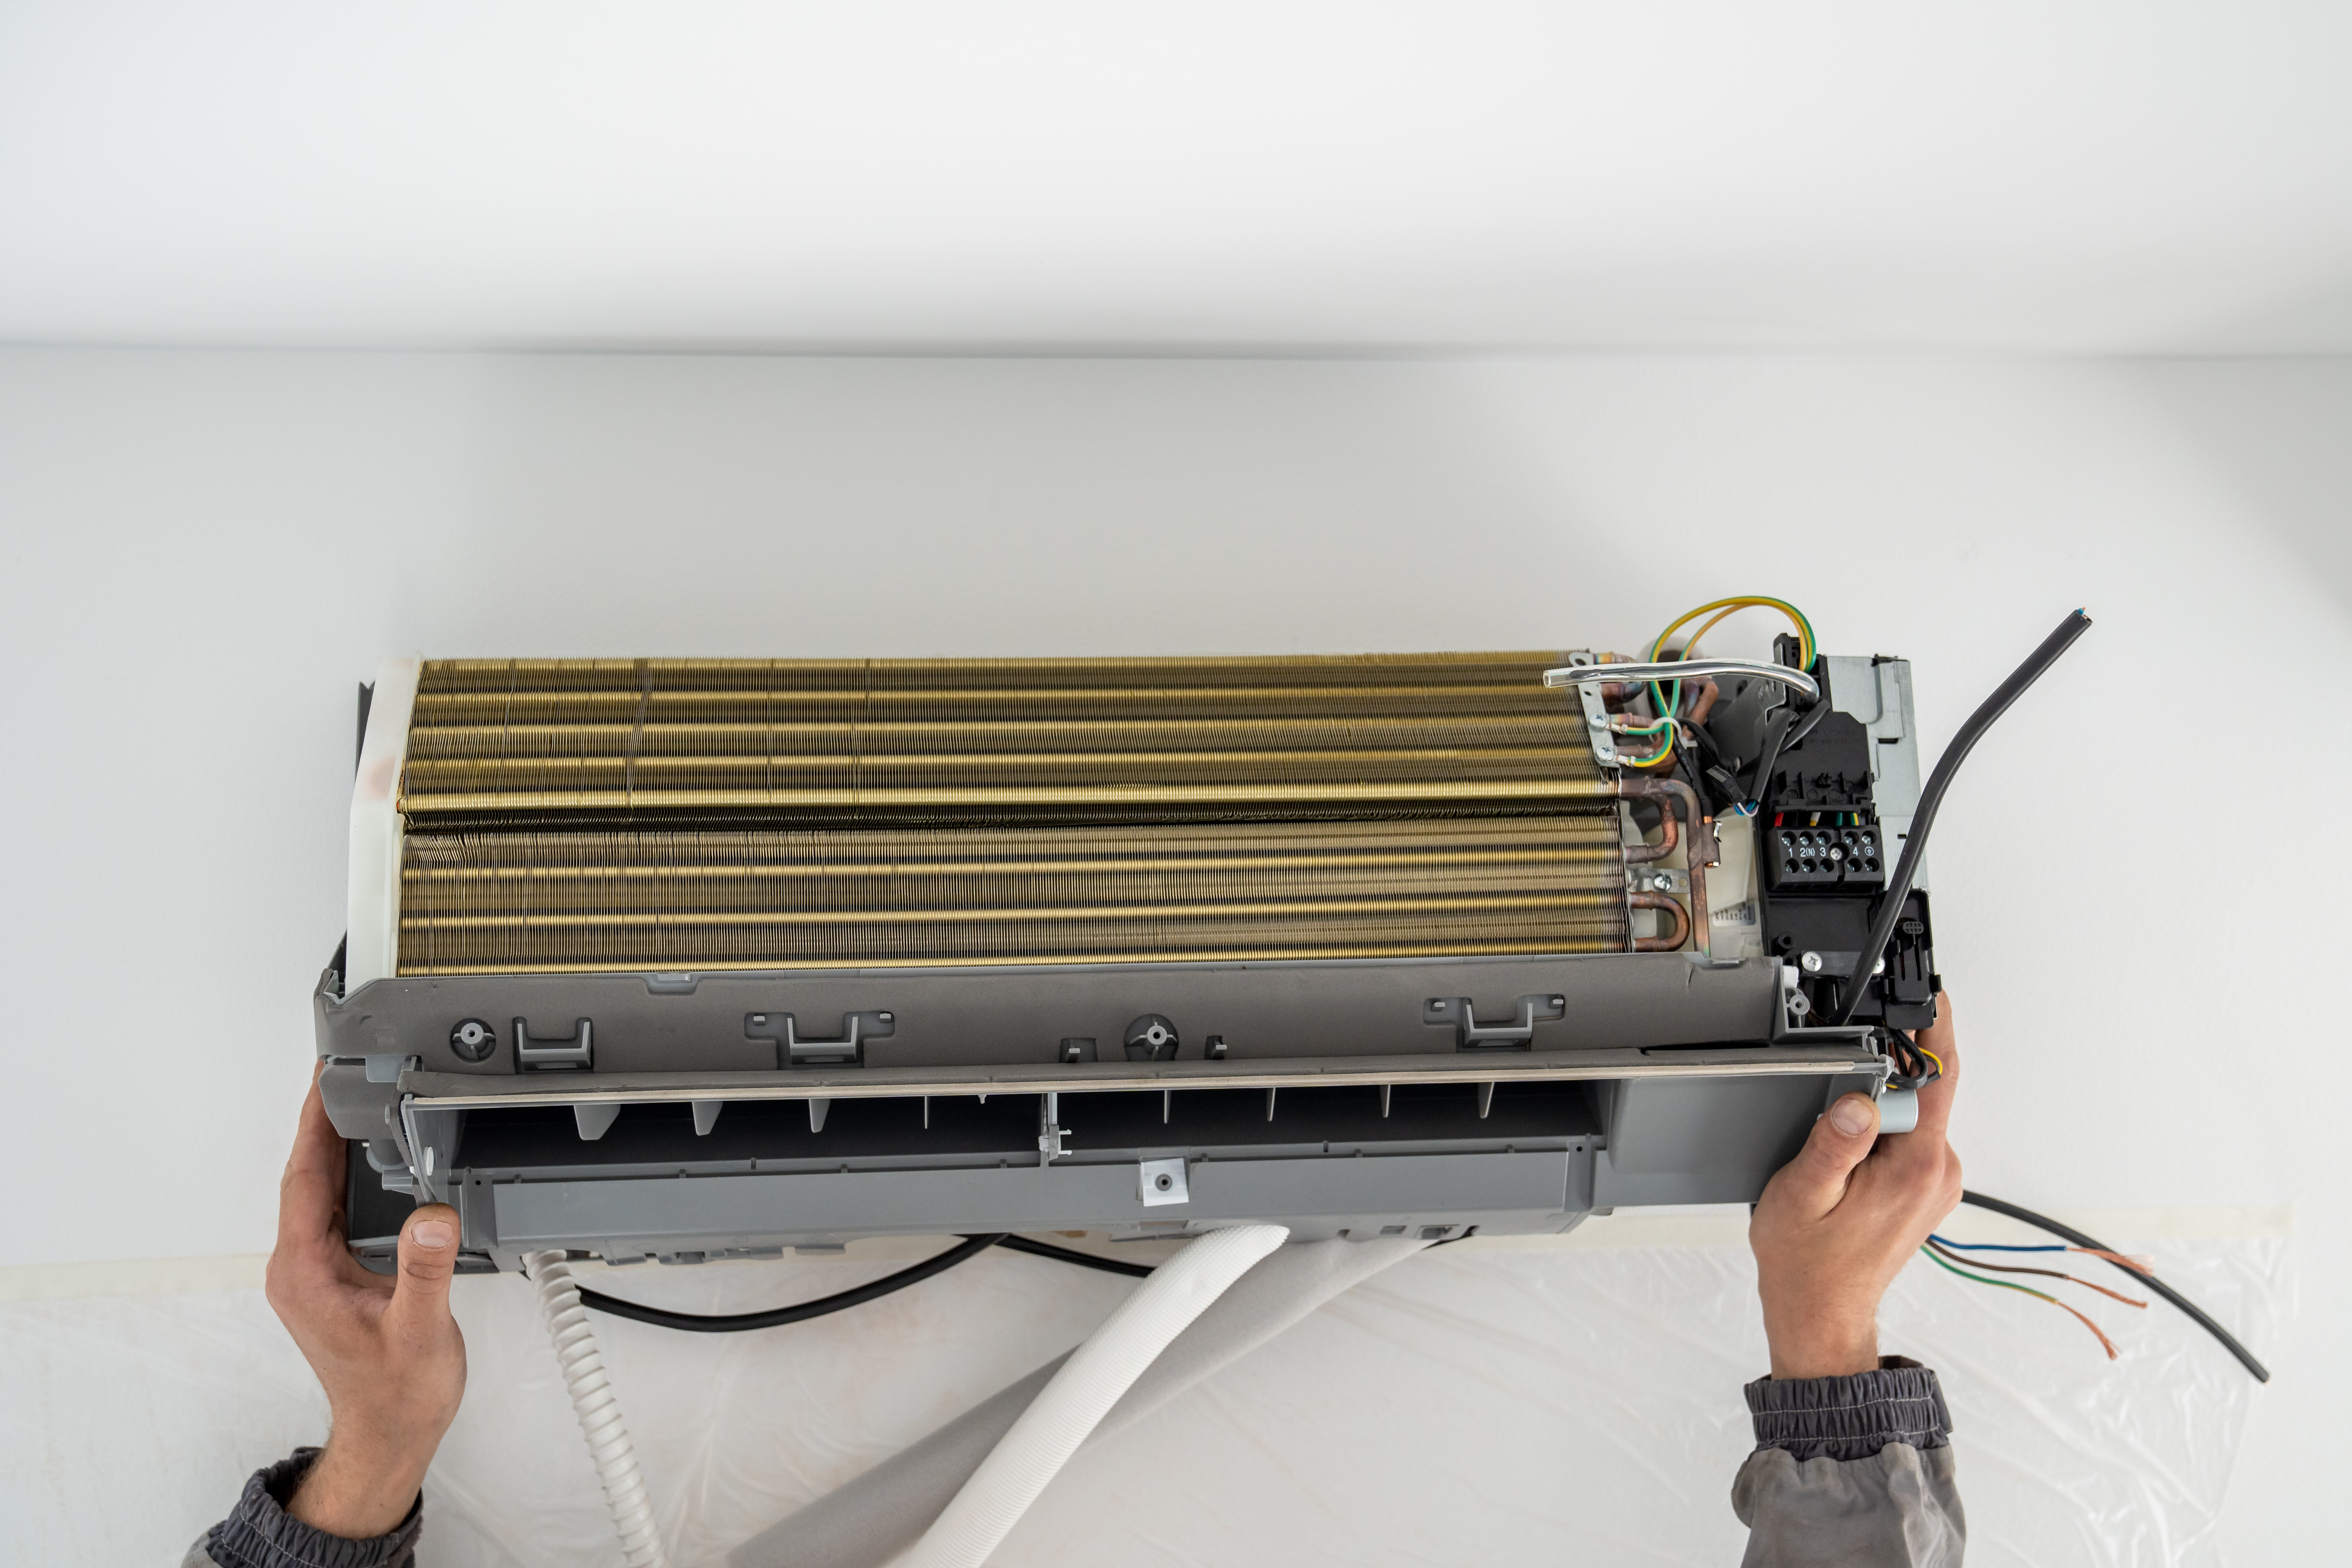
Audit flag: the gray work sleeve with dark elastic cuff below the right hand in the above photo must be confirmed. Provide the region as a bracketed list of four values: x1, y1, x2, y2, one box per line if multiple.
[1731, 1356, 1969, 1568]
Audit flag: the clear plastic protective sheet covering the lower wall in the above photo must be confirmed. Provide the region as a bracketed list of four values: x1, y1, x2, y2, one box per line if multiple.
[0, 1213, 2293, 1568]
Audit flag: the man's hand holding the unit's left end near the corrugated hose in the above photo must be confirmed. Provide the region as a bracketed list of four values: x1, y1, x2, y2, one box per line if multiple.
[268, 1084, 466, 1540]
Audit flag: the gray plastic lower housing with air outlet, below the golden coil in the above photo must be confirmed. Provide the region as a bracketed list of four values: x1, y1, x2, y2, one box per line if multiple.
[315, 952, 1884, 1267]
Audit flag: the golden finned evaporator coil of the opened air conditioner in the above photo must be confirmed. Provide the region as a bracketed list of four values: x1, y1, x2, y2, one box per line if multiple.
[397, 653, 1628, 973]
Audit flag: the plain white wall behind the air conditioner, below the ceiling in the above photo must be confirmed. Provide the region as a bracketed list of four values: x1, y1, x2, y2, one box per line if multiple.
[0, 350, 2352, 1561]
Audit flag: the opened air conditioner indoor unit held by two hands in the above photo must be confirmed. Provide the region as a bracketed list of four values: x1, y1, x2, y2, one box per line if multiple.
[315, 630, 1936, 1269]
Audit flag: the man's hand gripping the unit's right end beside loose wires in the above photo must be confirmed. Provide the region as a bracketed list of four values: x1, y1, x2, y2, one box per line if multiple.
[1748, 995, 1959, 1377]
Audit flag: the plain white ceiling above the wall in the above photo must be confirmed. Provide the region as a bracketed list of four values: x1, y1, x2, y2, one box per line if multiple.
[0, 0, 2352, 353]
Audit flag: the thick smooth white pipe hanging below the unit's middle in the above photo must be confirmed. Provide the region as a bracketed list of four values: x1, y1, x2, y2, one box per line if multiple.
[898, 1225, 1291, 1568]
